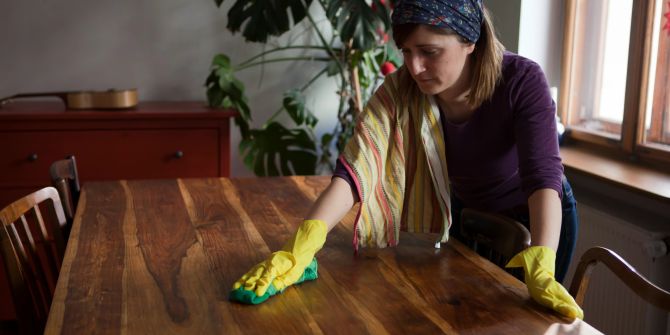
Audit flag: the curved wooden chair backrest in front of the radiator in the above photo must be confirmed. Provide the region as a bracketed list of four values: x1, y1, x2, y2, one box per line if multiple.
[570, 247, 670, 312]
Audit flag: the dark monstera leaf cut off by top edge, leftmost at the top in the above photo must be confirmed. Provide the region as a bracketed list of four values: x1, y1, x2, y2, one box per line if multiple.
[214, 0, 312, 43]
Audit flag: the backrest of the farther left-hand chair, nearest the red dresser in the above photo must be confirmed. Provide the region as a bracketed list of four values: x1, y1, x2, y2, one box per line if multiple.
[49, 156, 80, 224]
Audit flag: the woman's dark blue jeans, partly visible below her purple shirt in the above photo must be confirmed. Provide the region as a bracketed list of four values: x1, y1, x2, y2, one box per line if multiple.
[449, 176, 579, 283]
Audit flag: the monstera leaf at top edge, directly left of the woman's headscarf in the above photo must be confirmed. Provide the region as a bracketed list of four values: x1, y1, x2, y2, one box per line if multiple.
[326, 0, 390, 51]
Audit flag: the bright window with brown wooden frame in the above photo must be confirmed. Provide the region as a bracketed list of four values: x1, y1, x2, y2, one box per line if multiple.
[559, 0, 670, 166]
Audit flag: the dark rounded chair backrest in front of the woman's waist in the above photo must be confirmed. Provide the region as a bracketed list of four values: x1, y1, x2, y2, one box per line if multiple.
[460, 208, 530, 267]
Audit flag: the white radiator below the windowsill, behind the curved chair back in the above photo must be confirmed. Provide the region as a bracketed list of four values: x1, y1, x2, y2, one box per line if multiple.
[565, 203, 670, 335]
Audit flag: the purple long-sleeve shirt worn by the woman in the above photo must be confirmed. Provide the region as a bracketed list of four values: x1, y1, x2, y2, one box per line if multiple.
[334, 52, 563, 212]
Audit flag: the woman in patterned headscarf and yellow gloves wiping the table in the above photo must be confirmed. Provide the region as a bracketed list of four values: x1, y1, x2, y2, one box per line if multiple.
[231, 0, 583, 318]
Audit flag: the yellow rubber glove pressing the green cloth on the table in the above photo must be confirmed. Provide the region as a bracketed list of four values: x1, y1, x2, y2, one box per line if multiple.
[233, 220, 328, 297]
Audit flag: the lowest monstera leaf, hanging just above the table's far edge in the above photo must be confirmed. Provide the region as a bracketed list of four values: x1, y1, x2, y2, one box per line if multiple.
[240, 122, 317, 176]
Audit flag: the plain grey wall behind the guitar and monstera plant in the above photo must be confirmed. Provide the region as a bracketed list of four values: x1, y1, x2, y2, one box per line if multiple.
[0, 0, 336, 176]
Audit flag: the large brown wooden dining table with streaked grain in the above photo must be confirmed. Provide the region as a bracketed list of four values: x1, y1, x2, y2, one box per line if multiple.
[46, 177, 604, 335]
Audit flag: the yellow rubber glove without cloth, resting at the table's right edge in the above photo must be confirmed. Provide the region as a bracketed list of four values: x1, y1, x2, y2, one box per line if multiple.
[505, 246, 584, 319]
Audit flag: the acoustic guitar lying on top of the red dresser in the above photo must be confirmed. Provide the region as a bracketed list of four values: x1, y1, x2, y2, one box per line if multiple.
[0, 88, 137, 109]
